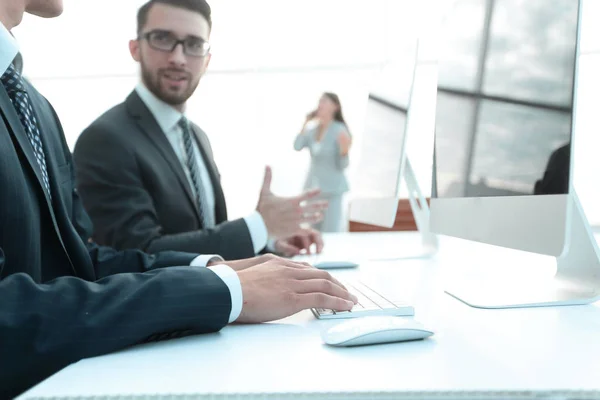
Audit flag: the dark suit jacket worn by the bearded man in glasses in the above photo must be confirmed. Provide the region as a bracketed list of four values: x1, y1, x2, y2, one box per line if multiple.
[74, 91, 255, 260]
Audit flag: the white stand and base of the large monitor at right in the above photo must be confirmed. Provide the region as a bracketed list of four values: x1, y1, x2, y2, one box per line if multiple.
[446, 190, 600, 309]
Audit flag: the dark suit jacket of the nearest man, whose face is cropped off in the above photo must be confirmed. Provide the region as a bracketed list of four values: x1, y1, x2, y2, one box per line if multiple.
[0, 78, 231, 398]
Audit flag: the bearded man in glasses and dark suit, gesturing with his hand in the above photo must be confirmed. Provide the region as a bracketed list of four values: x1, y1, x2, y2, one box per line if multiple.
[74, 0, 326, 259]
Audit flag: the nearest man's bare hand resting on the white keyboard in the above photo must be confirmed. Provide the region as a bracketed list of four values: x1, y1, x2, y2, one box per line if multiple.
[237, 256, 358, 323]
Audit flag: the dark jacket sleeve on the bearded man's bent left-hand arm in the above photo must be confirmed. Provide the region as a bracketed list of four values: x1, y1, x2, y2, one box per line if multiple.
[74, 128, 255, 260]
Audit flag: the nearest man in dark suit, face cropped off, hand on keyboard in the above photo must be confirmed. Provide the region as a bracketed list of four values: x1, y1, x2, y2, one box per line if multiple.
[0, 0, 355, 398]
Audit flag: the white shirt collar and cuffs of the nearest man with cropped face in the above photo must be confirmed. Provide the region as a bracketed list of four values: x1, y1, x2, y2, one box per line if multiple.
[0, 23, 243, 322]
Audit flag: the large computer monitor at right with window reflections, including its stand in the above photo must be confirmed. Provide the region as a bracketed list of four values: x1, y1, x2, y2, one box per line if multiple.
[431, 0, 600, 308]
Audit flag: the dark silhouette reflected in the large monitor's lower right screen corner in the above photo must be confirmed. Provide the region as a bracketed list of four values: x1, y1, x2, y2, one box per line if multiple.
[534, 143, 571, 195]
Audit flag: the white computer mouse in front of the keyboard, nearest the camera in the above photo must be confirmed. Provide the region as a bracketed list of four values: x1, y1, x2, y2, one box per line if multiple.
[321, 316, 433, 346]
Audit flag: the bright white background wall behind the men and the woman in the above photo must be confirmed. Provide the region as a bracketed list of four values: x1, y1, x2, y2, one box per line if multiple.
[14, 0, 600, 224]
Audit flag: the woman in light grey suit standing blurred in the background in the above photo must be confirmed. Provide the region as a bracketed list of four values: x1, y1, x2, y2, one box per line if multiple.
[294, 93, 352, 232]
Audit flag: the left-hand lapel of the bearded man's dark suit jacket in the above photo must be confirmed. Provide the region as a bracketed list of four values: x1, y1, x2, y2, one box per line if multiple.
[126, 91, 202, 222]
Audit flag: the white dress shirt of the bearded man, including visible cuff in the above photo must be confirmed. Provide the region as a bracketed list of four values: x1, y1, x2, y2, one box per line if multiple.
[135, 83, 272, 253]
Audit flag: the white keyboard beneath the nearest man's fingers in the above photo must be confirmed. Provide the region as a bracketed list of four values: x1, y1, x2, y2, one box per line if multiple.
[312, 281, 415, 319]
